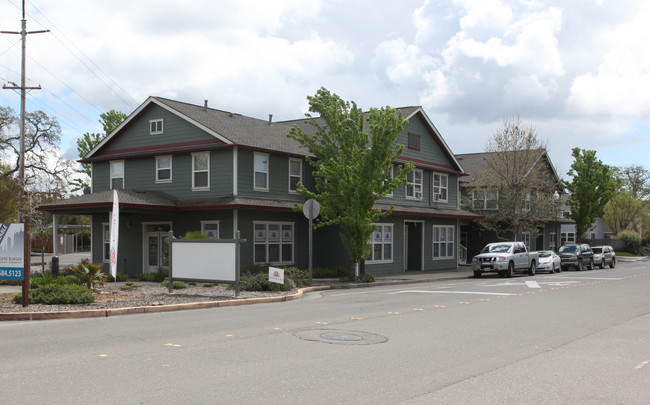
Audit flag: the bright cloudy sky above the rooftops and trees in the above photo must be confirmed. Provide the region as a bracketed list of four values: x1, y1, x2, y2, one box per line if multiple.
[0, 0, 650, 176]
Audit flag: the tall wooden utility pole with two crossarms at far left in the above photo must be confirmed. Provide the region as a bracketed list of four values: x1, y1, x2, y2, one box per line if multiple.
[0, 0, 49, 307]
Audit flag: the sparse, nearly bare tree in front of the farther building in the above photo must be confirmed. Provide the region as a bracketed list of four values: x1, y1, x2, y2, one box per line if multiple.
[464, 117, 560, 239]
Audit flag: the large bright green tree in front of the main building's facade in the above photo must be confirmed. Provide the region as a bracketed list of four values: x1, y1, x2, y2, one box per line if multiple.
[287, 88, 414, 276]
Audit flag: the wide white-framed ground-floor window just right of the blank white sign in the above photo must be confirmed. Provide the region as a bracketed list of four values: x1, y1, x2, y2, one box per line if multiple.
[253, 222, 294, 264]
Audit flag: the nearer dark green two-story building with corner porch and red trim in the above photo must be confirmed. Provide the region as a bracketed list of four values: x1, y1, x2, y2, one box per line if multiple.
[40, 97, 476, 276]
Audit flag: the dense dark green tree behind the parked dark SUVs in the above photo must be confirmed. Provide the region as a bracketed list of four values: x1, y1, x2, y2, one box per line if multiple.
[562, 148, 619, 240]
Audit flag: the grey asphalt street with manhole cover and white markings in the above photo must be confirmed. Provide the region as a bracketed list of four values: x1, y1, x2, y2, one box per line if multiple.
[0, 262, 650, 404]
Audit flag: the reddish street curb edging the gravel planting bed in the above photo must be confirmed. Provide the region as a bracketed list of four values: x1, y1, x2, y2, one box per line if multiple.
[0, 286, 330, 321]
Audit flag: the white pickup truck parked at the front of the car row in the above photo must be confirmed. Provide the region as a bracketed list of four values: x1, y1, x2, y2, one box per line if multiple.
[472, 242, 539, 278]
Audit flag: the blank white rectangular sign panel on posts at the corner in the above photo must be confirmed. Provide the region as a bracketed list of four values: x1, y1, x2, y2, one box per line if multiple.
[171, 240, 235, 283]
